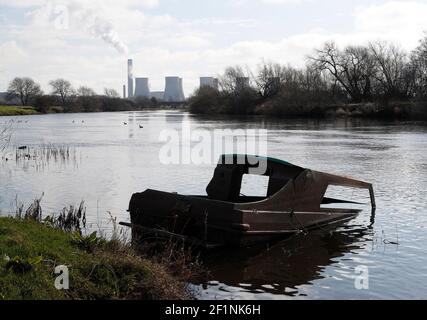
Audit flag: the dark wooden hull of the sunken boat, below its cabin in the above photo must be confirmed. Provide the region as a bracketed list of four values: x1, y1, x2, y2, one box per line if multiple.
[129, 190, 360, 247]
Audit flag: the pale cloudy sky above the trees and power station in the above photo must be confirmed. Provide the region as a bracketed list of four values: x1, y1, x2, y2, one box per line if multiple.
[0, 0, 427, 96]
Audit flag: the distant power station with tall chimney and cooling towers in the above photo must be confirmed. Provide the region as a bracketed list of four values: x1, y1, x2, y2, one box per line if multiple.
[123, 59, 217, 103]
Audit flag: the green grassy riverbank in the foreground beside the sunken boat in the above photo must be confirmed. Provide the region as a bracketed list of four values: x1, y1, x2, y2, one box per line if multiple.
[0, 218, 188, 300]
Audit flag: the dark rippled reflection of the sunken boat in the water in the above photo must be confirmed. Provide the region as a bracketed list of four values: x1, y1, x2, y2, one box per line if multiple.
[203, 220, 371, 296]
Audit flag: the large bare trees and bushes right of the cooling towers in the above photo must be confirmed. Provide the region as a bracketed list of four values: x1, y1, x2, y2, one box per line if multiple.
[189, 35, 427, 116]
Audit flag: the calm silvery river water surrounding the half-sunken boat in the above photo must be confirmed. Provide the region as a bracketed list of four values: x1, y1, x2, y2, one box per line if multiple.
[0, 111, 427, 299]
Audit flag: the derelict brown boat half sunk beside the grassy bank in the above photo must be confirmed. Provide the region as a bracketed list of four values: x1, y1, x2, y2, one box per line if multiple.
[125, 155, 376, 248]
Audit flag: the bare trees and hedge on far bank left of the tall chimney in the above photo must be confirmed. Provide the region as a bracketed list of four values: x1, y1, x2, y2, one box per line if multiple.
[7, 77, 157, 113]
